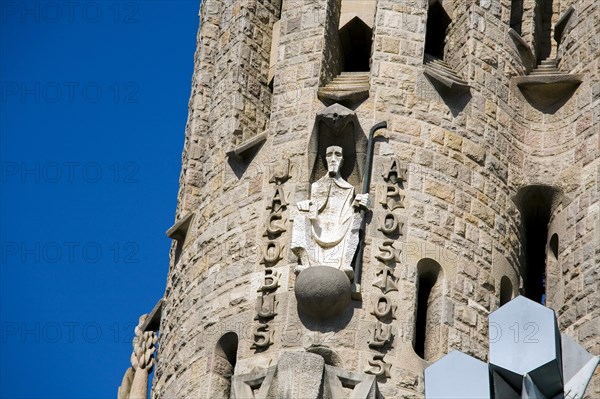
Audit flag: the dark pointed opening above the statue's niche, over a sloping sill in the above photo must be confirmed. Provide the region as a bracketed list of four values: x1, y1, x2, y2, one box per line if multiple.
[339, 17, 373, 72]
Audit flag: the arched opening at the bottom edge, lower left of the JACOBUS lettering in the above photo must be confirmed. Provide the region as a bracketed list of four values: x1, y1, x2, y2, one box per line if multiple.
[210, 332, 238, 398]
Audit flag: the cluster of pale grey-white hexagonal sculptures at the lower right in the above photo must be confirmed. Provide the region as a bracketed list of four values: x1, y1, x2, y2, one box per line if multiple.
[425, 296, 600, 399]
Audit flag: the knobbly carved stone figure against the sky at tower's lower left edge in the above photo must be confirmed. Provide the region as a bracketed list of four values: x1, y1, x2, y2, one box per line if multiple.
[117, 315, 158, 399]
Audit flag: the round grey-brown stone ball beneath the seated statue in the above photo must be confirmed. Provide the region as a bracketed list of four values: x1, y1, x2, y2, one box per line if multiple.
[295, 266, 351, 320]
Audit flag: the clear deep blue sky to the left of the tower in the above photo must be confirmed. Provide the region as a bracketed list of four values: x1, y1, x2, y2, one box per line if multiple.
[0, 0, 199, 398]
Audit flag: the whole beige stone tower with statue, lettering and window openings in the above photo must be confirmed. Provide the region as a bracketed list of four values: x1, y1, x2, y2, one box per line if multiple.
[127, 0, 600, 399]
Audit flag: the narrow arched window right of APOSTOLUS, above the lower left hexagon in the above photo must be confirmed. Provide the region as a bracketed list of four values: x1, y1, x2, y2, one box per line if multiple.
[413, 259, 443, 361]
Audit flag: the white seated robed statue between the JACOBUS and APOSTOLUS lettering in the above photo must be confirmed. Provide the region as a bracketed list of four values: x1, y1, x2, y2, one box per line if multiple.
[291, 146, 370, 281]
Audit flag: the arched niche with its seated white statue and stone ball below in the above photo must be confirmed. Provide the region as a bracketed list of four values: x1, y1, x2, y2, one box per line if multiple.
[291, 104, 369, 320]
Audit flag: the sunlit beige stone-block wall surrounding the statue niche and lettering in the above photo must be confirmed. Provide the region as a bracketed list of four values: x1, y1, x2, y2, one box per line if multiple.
[152, 0, 600, 399]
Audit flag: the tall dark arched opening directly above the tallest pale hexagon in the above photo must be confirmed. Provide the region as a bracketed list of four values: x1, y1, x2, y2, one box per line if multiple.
[515, 185, 558, 304]
